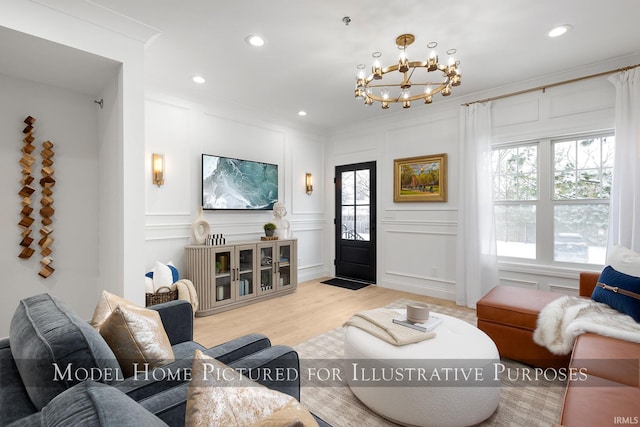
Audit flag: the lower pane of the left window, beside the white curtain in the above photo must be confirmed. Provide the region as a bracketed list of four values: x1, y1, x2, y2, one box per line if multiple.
[495, 205, 536, 259]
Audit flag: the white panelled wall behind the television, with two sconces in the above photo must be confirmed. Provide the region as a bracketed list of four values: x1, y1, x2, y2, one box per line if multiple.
[145, 93, 325, 281]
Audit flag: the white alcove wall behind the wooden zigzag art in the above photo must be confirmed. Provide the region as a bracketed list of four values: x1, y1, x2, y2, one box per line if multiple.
[0, 74, 99, 336]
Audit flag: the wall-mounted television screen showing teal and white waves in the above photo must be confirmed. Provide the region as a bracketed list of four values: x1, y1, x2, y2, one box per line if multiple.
[202, 154, 278, 210]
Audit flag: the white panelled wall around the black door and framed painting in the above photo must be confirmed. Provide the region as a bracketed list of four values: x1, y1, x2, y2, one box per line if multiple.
[325, 106, 458, 299]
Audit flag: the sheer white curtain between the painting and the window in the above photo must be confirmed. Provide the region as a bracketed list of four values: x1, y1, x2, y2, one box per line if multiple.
[456, 102, 498, 308]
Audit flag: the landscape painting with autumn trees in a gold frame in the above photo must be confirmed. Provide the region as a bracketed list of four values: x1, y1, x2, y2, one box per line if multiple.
[393, 154, 447, 202]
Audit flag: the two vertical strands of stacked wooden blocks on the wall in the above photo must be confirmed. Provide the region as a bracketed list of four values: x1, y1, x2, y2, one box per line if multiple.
[18, 116, 56, 279]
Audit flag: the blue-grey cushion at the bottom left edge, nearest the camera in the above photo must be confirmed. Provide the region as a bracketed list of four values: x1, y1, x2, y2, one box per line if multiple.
[11, 381, 166, 427]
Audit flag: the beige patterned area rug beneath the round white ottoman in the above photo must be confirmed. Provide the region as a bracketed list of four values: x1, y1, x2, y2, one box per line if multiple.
[295, 300, 566, 427]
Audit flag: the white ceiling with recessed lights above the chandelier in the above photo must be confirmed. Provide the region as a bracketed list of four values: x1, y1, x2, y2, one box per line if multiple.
[3, 0, 640, 129]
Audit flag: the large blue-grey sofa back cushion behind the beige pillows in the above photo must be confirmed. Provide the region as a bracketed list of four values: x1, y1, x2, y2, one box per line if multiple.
[9, 294, 120, 410]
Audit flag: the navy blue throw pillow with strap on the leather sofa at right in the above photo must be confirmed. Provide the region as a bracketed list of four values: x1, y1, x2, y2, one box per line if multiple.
[591, 265, 640, 322]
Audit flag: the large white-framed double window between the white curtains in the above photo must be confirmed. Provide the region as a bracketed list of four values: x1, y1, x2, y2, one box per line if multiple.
[492, 134, 615, 264]
